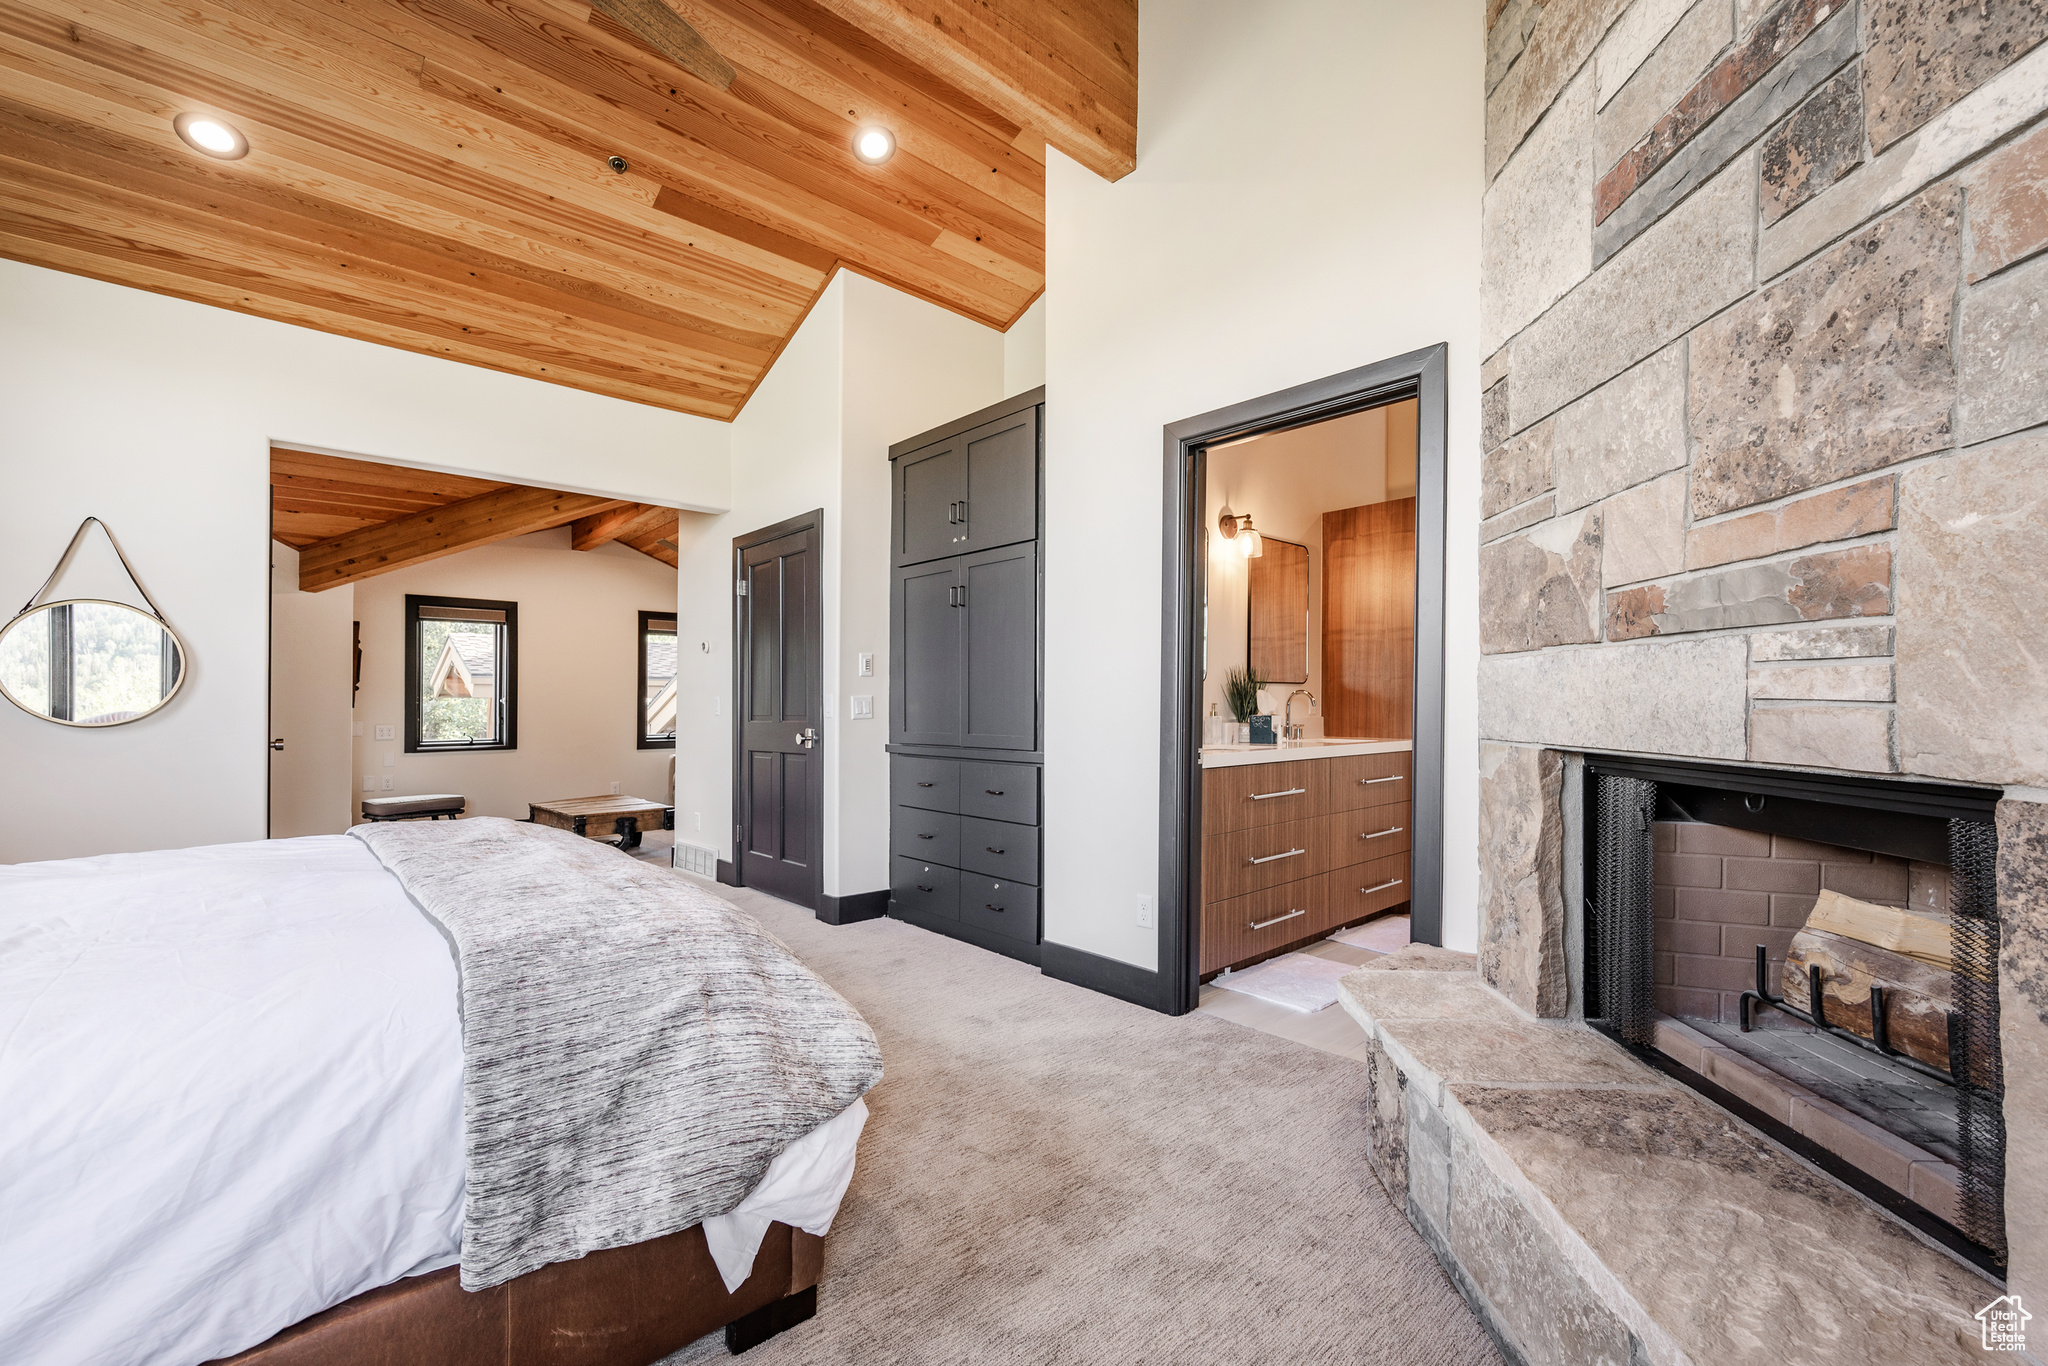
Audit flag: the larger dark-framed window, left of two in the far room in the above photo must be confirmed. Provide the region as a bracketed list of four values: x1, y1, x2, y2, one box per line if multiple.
[406, 594, 518, 754]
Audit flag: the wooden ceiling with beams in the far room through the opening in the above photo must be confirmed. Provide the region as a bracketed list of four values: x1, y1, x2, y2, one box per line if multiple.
[270, 446, 680, 592]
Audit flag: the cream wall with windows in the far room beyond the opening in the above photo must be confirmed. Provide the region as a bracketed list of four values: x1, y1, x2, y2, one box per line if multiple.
[348, 526, 676, 819]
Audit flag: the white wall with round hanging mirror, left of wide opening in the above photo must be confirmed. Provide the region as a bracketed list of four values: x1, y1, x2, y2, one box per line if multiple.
[0, 260, 731, 862]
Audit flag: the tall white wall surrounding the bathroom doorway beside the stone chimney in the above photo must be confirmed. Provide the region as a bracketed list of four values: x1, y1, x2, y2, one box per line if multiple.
[1044, 0, 1485, 967]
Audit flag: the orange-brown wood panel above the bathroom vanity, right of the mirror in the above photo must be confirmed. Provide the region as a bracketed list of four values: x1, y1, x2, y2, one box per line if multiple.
[1321, 498, 1415, 739]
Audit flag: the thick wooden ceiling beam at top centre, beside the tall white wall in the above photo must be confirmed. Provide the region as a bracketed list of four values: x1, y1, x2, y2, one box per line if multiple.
[798, 0, 1139, 180]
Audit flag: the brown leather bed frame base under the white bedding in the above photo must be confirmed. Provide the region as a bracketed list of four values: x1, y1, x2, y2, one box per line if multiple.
[209, 1223, 825, 1366]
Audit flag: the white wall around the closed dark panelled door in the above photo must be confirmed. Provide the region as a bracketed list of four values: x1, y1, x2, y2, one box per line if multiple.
[676, 270, 1003, 897]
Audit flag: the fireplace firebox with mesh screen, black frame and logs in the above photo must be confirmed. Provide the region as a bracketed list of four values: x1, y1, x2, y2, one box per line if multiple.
[1581, 756, 2005, 1272]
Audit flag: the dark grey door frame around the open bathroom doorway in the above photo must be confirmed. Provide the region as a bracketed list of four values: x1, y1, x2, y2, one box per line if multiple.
[1147, 342, 1450, 1016]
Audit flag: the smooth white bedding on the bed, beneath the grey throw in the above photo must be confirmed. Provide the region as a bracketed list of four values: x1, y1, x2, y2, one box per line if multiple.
[0, 836, 866, 1366]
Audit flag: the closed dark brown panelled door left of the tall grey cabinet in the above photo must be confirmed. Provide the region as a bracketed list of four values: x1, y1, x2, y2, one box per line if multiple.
[733, 512, 825, 909]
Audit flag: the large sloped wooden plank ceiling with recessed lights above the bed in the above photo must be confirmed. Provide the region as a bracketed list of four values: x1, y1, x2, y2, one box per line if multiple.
[0, 0, 1137, 420]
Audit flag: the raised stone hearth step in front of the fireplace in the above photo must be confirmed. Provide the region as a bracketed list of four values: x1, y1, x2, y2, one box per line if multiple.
[1339, 954, 2001, 1366]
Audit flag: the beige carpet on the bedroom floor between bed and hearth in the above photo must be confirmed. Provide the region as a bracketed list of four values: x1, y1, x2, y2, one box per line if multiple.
[670, 874, 1501, 1366]
